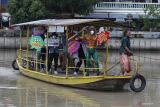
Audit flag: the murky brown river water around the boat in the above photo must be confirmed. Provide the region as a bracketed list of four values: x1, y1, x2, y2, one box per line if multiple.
[0, 50, 160, 107]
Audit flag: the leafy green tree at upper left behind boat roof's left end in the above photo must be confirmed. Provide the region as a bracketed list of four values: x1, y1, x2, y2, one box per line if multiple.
[8, 0, 49, 23]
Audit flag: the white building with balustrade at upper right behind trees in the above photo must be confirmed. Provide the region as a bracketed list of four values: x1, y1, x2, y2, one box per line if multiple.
[78, 0, 160, 22]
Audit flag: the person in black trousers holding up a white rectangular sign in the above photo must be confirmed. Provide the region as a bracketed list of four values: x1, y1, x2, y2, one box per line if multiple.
[45, 32, 60, 75]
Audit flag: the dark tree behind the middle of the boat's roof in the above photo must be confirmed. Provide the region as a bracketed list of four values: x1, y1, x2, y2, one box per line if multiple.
[42, 0, 98, 16]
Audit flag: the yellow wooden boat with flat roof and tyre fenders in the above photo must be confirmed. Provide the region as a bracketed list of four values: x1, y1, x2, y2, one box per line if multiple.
[12, 19, 146, 92]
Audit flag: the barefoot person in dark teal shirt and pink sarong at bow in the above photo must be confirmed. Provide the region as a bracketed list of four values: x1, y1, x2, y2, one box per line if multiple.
[119, 30, 133, 75]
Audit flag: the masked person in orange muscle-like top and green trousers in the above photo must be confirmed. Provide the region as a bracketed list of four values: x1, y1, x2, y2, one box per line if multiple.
[78, 26, 100, 76]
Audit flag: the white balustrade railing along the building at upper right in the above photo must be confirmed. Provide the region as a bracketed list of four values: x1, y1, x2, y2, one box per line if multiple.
[95, 2, 160, 9]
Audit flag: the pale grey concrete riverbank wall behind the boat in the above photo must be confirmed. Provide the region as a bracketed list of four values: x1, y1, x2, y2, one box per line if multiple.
[0, 30, 160, 50]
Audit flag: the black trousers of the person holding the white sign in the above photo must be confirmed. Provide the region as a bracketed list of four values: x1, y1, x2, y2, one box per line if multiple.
[48, 53, 59, 71]
